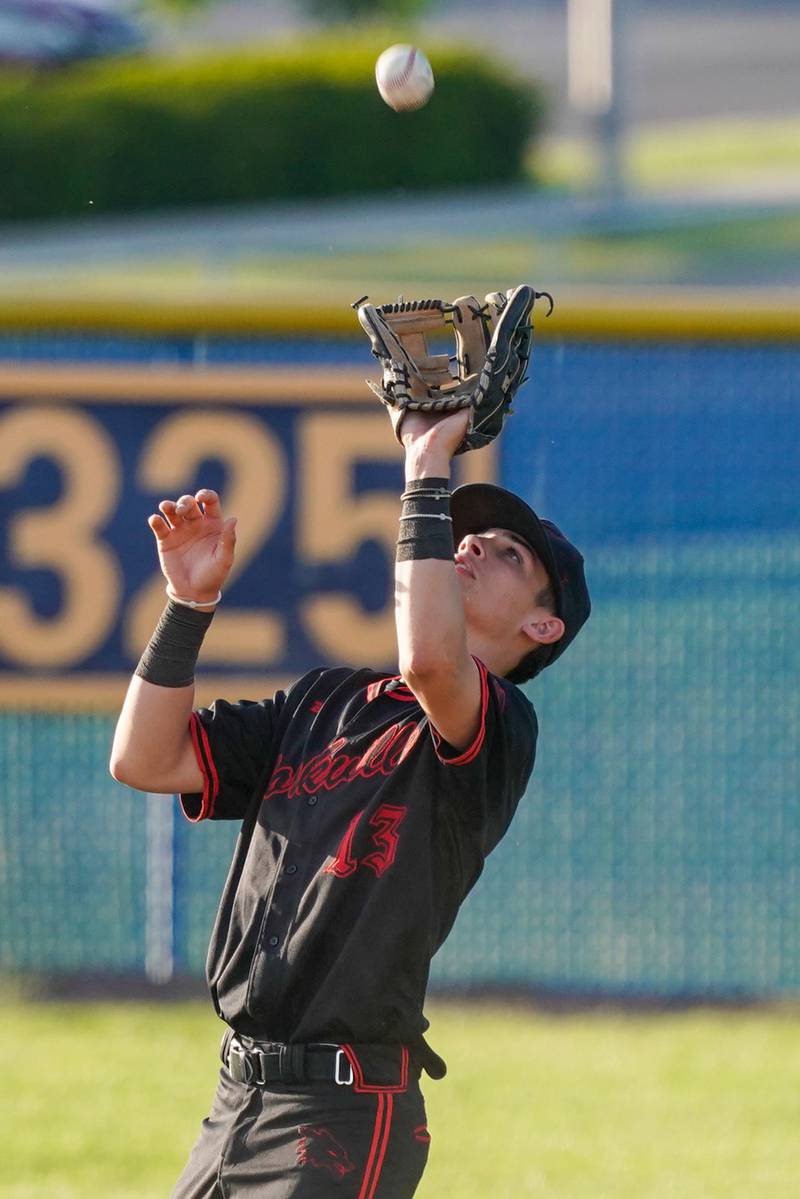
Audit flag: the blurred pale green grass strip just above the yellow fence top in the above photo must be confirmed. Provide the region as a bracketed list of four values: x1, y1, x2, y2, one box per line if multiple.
[0, 206, 800, 304]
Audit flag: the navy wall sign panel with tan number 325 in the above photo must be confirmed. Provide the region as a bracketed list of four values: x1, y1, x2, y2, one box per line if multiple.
[0, 385, 493, 671]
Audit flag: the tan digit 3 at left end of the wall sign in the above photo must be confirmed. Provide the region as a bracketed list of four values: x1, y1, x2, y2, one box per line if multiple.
[0, 408, 122, 667]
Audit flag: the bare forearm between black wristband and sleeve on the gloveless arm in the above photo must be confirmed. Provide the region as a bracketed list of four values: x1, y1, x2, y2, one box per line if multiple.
[109, 675, 201, 794]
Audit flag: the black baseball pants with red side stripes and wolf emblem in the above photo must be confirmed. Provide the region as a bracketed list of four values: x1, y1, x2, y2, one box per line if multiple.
[173, 1045, 431, 1199]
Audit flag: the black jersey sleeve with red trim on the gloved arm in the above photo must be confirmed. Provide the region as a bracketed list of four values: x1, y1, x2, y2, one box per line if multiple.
[431, 658, 539, 856]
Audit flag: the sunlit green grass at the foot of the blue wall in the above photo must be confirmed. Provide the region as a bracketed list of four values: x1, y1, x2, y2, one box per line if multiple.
[0, 1002, 800, 1199]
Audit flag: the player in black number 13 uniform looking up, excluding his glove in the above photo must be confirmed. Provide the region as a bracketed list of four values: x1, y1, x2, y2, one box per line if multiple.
[112, 285, 589, 1199]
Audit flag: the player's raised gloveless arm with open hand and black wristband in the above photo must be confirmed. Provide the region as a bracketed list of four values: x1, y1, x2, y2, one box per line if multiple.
[110, 489, 236, 794]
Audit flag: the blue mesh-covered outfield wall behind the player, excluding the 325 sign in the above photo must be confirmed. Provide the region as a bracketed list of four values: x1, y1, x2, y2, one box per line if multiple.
[0, 338, 800, 998]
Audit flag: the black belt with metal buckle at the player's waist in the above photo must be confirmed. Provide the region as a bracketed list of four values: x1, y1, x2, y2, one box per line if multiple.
[219, 1029, 353, 1086]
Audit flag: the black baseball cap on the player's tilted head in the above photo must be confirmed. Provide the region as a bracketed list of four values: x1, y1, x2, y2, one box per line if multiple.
[450, 483, 591, 682]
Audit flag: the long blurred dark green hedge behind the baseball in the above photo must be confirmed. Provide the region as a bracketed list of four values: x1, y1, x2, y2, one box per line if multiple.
[0, 41, 542, 218]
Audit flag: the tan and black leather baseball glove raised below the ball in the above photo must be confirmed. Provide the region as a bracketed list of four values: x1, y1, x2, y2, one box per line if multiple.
[353, 283, 553, 453]
